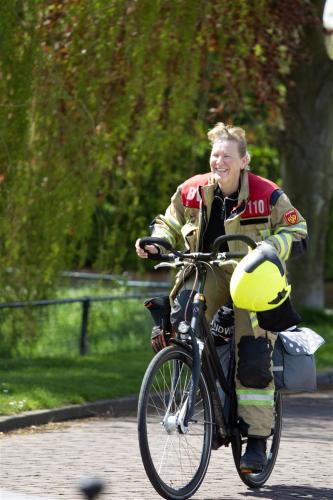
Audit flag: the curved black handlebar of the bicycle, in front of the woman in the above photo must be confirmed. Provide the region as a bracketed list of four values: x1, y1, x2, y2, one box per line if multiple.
[139, 234, 257, 261]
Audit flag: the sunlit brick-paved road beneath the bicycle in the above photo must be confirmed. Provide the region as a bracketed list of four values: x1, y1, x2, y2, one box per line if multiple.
[0, 393, 333, 500]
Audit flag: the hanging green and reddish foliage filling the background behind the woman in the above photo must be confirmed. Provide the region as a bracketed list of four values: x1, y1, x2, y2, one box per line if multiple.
[0, 0, 318, 301]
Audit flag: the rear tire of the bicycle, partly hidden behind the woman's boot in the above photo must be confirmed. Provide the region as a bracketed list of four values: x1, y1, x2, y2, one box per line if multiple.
[232, 391, 282, 488]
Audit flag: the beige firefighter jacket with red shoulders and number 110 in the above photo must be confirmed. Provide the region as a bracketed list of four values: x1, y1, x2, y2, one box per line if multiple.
[152, 170, 307, 262]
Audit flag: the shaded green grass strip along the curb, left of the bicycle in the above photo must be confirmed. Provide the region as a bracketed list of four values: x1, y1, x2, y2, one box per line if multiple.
[0, 348, 153, 415]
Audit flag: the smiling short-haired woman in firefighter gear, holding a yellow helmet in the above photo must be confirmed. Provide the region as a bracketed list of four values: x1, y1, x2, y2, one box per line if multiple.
[135, 123, 307, 473]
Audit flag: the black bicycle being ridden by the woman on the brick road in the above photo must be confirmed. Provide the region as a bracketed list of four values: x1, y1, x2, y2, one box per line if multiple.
[138, 235, 282, 500]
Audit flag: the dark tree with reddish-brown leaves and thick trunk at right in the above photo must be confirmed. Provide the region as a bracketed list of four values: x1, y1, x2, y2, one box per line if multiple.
[200, 0, 333, 308]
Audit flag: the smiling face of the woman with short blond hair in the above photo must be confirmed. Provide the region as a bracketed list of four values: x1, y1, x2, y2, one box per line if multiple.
[209, 139, 247, 196]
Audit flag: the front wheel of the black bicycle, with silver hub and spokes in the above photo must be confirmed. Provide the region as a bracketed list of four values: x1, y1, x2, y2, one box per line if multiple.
[138, 346, 213, 500]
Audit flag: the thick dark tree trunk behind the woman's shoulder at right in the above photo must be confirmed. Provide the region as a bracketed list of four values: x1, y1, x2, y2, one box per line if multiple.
[279, 15, 333, 308]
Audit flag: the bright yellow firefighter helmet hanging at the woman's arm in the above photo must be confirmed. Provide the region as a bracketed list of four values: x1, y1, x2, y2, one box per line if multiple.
[230, 244, 291, 311]
